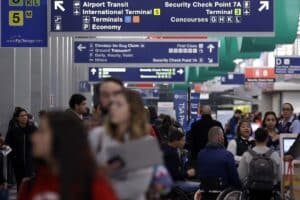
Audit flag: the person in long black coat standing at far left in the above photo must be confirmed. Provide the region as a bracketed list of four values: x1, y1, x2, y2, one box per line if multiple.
[5, 109, 37, 188]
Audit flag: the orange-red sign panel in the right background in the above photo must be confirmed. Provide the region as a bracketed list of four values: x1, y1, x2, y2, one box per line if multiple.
[245, 68, 276, 82]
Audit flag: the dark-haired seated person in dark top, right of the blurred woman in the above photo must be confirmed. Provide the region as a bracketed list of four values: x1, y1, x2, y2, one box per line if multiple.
[162, 127, 199, 193]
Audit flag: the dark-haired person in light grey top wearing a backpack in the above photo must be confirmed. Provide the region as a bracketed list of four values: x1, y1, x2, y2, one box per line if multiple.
[238, 128, 281, 200]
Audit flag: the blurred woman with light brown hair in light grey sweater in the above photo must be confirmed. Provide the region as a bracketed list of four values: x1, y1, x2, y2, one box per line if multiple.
[89, 89, 159, 200]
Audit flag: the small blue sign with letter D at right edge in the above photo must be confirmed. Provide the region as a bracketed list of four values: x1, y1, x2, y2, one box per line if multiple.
[275, 57, 300, 74]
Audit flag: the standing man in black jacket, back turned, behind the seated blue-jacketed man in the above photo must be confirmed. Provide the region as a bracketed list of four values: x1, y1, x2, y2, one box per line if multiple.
[187, 106, 223, 160]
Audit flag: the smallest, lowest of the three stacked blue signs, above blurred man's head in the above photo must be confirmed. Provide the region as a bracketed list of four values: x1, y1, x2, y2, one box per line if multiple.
[89, 67, 185, 83]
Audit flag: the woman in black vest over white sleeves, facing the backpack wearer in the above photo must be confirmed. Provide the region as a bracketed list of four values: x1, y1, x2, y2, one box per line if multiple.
[227, 120, 255, 162]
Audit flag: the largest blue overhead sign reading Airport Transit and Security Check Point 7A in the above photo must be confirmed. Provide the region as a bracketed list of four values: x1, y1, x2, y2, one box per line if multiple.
[51, 0, 274, 36]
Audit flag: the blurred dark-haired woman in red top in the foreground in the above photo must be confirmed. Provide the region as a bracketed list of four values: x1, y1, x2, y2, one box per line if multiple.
[18, 112, 117, 200]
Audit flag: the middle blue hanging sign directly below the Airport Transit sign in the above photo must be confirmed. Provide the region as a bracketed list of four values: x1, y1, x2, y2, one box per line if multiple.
[74, 41, 218, 67]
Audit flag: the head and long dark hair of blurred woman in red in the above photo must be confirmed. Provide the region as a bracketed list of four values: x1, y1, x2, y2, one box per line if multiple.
[32, 112, 96, 200]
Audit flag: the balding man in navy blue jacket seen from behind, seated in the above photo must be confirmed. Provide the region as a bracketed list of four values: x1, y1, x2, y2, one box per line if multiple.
[197, 127, 241, 189]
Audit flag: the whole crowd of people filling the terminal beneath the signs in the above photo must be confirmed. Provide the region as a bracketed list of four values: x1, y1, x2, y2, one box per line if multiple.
[2, 78, 300, 200]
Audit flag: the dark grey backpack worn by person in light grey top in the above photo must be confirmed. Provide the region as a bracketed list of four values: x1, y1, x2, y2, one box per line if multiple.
[248, 149, 276, 191]
